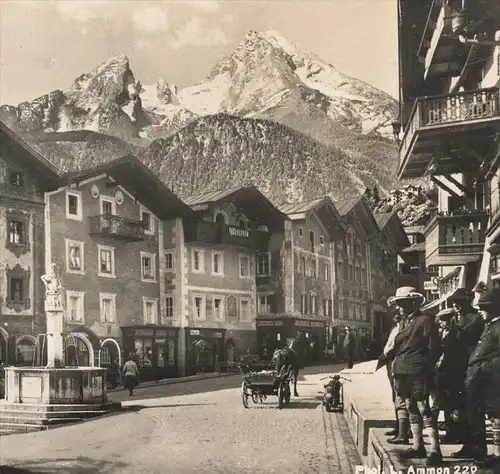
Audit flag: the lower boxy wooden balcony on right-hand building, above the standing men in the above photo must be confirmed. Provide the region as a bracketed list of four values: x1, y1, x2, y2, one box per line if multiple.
[425, 210, 489, 266]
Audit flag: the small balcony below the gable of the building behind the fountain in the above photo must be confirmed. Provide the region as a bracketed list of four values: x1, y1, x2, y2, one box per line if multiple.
[89, 214, 146, 242]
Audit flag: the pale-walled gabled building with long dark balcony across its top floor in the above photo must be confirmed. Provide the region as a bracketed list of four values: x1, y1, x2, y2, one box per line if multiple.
[169, 186, 285, 373]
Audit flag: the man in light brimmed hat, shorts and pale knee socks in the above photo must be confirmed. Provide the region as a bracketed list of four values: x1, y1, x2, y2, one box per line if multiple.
[392, 287, 442, 466]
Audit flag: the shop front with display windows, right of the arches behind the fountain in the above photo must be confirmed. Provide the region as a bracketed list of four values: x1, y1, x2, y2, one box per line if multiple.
[121, 326, 179, 381]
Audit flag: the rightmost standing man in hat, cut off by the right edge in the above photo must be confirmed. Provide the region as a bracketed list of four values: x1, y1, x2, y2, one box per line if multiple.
[453, 288, 500, 468]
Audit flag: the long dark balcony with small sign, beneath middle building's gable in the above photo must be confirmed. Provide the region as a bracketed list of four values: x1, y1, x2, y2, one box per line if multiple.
[184, 220, 269, 251]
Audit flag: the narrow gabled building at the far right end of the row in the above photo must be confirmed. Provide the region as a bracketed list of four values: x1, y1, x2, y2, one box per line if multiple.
[370, 212, 410, 341]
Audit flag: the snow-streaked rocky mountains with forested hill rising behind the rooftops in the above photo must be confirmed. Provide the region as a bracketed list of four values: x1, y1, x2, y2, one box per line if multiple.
[0, 31, 434, 225]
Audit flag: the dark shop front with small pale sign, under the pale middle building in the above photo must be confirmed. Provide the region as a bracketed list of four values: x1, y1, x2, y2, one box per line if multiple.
[186, 328, 228, 375]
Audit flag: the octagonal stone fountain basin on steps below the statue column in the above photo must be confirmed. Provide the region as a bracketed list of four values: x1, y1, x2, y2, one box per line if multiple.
[0, 367, 121, 431]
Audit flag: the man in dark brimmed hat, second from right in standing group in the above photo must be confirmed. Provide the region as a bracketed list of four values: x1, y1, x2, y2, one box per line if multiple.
[449, 288, 484, 443]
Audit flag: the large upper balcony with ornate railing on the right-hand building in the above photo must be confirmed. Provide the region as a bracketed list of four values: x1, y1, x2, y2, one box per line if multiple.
[398, 88, 500, 179]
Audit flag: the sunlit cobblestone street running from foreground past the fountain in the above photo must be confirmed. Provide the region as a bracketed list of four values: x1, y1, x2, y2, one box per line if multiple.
[0, 366, 359, 474]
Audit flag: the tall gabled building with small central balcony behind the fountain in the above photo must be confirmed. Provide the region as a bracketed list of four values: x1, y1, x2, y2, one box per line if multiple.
[44, 156, 191, 378]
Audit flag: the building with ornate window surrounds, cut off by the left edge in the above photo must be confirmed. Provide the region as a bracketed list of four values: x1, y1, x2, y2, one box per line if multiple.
[0, 122, 58, 365]
